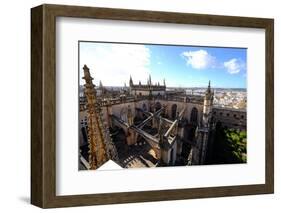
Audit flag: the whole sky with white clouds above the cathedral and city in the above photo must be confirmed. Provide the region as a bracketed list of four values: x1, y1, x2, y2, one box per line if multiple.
[79, 42, 247, 88]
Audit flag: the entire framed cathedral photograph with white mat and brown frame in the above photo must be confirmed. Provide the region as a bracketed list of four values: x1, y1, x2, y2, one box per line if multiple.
[31, 5, 274, 208]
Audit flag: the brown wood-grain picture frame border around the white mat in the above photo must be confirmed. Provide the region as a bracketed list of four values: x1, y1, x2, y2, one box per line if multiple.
[31, 5, 274, 208]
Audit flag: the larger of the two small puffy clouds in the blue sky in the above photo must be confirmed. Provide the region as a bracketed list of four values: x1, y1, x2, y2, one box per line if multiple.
[182, 50, 216, 69]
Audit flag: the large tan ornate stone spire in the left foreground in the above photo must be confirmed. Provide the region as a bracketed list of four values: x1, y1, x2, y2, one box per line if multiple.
[83, 65, 107, 169]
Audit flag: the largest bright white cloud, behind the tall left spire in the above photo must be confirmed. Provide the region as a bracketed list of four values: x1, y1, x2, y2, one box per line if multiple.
[80, 42, 150, 86]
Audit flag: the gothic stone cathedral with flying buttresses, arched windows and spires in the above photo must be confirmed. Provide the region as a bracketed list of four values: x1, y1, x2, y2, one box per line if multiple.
[79, 65, 246, 170]
